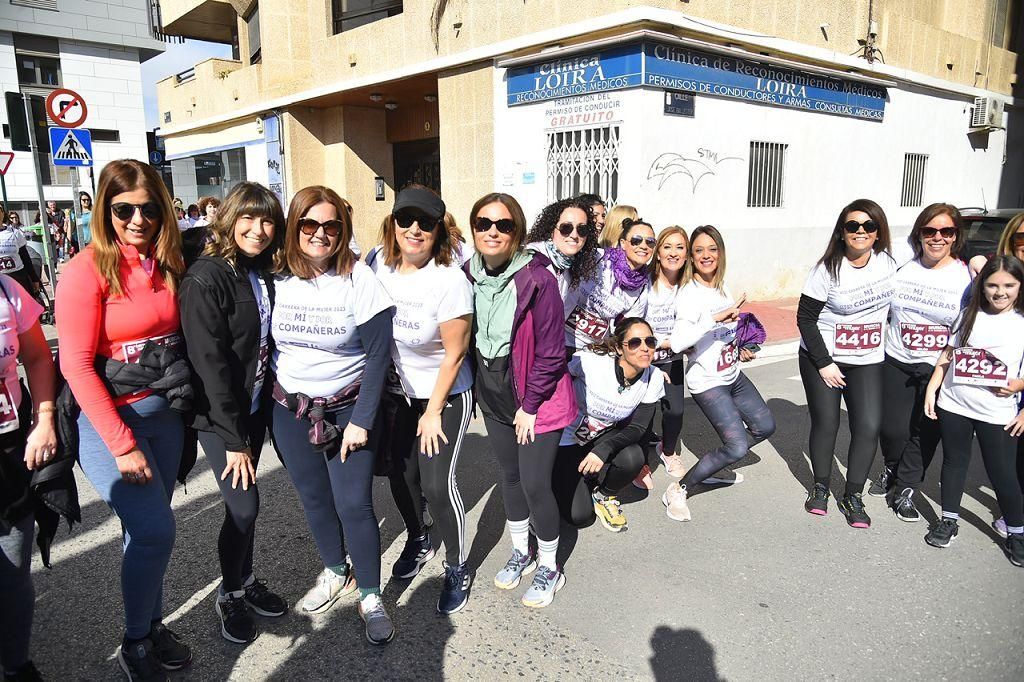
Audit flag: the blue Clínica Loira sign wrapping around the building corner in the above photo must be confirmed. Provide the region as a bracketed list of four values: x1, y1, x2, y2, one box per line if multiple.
[508, 41, 886, 121]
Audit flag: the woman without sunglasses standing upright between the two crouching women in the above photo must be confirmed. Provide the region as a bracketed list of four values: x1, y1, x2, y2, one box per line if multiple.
[633, 225, 690, 491]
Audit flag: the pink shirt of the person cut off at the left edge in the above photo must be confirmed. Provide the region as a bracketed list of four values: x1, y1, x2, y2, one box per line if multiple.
[0, 274, 43, 433]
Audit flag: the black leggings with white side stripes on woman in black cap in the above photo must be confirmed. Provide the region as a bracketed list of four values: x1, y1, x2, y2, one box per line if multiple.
[382, 391, 473, 566]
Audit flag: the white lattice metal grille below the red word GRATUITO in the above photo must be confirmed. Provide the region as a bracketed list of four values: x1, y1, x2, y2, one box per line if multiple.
[548, 126, 618, 202]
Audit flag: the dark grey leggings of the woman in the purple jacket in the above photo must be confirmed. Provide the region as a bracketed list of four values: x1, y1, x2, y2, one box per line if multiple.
[483, 416, 562, 542]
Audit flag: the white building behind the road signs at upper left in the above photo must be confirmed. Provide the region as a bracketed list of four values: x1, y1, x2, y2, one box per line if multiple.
[0, 0, 164, 223]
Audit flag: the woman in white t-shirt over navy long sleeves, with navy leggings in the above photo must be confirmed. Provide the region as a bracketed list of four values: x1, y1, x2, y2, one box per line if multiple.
[270, 185, 394, 644]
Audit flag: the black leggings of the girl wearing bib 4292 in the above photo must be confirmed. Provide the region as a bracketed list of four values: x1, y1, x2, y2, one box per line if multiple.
[936, 408, 1024, 526]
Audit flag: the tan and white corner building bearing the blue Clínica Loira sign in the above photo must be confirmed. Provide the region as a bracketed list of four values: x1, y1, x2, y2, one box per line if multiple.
[158, 0, 1024, 298]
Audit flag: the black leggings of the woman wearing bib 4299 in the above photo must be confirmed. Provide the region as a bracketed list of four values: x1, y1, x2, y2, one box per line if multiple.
[880, 355, 941, 493]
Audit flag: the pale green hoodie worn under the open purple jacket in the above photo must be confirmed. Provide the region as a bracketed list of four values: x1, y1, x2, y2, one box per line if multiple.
[469, 251, 534, 359]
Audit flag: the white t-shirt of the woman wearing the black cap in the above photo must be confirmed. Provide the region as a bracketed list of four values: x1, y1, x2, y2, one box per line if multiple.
[371, 257, 473, 400]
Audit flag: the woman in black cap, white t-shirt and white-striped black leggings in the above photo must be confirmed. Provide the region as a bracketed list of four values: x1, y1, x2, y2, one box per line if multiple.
[371, 187, 473, 614]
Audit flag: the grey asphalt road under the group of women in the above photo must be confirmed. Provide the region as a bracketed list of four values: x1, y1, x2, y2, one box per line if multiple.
[25, 355, 1024, 681]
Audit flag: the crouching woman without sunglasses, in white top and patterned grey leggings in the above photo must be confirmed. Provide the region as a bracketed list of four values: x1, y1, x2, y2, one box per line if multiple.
[662, 225, 775, 521]
